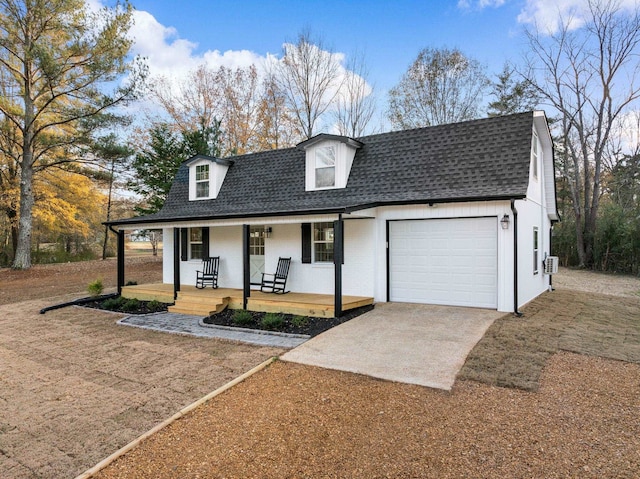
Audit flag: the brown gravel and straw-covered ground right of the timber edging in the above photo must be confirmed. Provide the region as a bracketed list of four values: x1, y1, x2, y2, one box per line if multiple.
[91, 270, 640, 479]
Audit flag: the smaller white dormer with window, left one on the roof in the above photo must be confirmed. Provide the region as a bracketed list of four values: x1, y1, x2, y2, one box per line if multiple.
[185, 155, 233, 201]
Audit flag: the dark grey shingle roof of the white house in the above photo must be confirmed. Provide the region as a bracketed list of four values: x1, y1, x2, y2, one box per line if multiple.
[112, 112, 533, 224]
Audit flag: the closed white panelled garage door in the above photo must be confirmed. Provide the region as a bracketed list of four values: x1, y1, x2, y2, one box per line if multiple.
[389, 218, 498, 308]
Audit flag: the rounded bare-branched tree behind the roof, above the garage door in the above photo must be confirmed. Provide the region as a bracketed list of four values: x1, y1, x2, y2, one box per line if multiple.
[388, 48, 489, 129]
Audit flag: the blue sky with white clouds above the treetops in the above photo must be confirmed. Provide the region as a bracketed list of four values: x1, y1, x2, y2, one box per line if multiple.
[97, 0, 636, 131]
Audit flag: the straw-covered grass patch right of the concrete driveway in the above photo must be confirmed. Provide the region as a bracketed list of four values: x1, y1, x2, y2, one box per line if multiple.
[458, 290, 640, 391]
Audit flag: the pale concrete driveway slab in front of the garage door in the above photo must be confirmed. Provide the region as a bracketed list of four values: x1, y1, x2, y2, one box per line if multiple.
[281, 303, 505, 390]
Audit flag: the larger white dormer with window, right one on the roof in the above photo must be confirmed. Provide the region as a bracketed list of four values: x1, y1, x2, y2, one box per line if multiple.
[297, 133, 362, 191]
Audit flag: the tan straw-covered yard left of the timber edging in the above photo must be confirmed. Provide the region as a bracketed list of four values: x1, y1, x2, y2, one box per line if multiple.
[0, 258, 282, 479]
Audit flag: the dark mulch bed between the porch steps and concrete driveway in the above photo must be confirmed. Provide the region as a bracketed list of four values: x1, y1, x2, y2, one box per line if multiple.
[204, 306, 373, 336]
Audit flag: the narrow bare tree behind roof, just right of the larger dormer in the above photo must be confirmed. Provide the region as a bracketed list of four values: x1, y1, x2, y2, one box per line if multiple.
[335, 55, 376, 138]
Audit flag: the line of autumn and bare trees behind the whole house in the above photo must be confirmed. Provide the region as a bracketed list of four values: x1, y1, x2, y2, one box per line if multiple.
[0, 0, 640, 274]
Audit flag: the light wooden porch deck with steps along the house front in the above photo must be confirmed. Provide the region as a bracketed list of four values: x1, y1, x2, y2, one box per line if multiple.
[122, 283, 373, 318]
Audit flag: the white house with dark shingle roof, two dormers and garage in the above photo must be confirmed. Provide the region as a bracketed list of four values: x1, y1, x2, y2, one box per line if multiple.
[110, 111, 559, 315]
